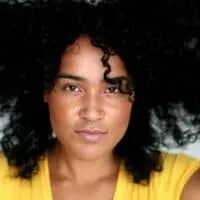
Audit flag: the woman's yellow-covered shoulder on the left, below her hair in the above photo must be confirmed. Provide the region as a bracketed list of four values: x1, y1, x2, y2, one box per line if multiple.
[0, 153, 48, 200]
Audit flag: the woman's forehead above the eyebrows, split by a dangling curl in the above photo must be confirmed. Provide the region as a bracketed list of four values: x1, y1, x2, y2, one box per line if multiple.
[60, 36, 128, 80]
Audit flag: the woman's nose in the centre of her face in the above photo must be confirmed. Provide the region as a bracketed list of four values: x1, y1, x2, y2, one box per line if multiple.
[79, 92, 105, 122]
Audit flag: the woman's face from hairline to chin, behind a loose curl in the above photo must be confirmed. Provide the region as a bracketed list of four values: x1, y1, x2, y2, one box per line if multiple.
[45, 37, 132, 160]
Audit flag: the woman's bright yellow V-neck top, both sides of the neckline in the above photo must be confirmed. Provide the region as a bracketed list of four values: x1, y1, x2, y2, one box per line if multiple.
[0, 153, 200, 200]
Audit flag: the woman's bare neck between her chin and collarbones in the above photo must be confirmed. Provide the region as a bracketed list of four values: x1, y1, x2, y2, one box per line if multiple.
[49, 141, 120, 184]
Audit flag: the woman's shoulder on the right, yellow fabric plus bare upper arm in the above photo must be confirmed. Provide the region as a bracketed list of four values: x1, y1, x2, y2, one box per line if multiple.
[116, 152, 200, 200]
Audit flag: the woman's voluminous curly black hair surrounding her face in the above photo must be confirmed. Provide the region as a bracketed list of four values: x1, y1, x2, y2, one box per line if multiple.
[0, 0, 200, 183]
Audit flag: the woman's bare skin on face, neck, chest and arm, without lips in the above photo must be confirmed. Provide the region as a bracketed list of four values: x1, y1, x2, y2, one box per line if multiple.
[44, 36, 200, 200]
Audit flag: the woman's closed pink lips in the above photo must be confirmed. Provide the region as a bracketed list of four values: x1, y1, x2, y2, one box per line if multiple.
[75, 129, 107, 142]
